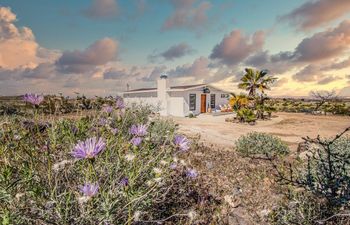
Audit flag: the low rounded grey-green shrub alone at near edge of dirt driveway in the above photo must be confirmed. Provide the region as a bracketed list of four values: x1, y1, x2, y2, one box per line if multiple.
[236, 132, 289, 158]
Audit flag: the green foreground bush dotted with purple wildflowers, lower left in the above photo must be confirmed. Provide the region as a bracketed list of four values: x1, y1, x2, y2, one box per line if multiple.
[0, 103, 219, 224]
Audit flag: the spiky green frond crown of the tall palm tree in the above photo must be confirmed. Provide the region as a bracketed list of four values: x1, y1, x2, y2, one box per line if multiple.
[238, 68, 277, 97]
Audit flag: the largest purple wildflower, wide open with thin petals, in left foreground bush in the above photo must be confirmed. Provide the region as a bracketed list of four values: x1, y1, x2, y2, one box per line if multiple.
[71, 137, 106, 159]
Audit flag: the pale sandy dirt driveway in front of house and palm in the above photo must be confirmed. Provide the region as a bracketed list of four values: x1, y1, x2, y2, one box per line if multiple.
[173, 112, 350, 150]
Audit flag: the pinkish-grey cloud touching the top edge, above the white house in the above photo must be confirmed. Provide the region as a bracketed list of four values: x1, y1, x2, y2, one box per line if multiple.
[162, 0, 211, 31]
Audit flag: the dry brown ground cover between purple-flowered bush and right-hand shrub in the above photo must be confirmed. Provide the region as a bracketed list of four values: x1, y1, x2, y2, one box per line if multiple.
[188, 142, 280, 224]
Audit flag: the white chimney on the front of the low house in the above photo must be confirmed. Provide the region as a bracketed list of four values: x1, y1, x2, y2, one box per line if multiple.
[157, 75, 170, 116]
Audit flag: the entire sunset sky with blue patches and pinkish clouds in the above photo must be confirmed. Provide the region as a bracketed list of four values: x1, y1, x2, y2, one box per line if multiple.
[0, 0, 350, 96]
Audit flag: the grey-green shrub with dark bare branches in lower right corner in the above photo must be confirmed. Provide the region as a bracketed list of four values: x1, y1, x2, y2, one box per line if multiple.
[272, 127, 350, 224]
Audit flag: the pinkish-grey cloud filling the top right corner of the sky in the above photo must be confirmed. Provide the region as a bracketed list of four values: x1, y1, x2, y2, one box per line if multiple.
[280, 0, 350, 30]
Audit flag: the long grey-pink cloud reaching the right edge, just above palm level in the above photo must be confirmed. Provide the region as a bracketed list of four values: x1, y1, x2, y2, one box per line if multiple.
[245, 20, 350, 75]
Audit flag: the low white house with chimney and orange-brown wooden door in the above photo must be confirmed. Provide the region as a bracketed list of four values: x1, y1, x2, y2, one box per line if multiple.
[123, 75, 229, 117]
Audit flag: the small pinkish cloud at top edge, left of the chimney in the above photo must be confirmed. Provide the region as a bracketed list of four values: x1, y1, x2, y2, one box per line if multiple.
[83, 0, 118, 19]
